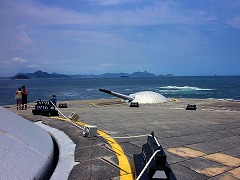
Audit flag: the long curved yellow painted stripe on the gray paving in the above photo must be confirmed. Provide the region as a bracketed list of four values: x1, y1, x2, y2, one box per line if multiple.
[52, 117, 133, 180]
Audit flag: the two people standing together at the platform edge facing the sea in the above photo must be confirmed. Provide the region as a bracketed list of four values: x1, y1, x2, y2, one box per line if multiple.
[15, 86, 28, 110]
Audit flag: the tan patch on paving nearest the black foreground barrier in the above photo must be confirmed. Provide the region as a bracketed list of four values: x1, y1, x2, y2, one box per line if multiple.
[167, 147, 206, 157]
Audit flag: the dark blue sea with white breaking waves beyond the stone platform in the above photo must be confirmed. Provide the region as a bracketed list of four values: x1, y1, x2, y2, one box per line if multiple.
[0, 76, 240, 105]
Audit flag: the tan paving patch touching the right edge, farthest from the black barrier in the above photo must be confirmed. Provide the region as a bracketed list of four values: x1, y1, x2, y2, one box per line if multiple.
[203, 153, 240, 167]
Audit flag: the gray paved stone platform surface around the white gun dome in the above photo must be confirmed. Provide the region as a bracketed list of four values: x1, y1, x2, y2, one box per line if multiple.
[6, 99, 240, 180]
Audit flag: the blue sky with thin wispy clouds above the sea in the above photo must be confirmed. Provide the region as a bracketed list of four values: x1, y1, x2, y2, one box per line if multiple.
[0, 0, 240, 77]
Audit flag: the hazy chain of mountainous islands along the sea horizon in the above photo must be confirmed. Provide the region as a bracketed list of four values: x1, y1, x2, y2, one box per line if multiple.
[11, 70, 173, 79]
